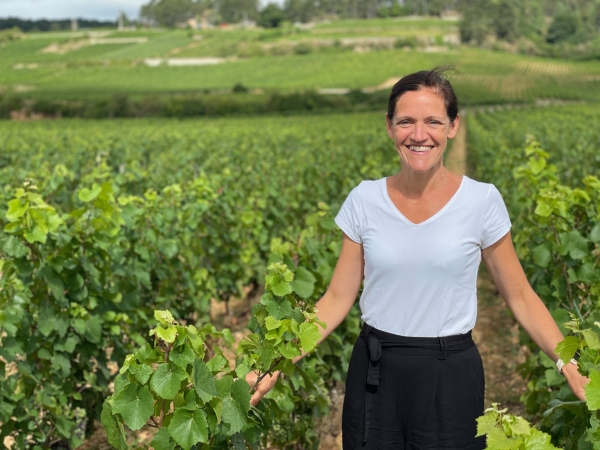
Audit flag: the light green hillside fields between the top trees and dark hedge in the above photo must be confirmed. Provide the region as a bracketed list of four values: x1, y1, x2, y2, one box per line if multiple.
[0, 18, 600, 108]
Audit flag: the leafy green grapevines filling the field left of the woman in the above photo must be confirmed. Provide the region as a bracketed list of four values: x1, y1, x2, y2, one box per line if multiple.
[0, 115, 394, 449]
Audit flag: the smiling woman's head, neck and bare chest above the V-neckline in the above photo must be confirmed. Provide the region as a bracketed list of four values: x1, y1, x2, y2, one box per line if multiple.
[386, 70, 461, 222]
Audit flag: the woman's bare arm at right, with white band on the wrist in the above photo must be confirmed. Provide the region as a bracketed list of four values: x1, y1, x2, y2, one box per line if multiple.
[482, 232, 589, 400]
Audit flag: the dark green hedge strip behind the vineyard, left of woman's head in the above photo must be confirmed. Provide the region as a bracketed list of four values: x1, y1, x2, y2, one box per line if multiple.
[0, 89, 387, 120]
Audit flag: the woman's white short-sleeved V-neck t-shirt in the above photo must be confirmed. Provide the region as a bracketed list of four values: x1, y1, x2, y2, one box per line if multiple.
[335, 177, 511, 337]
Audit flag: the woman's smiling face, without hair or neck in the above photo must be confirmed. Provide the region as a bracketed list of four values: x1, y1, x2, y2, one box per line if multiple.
[386, 88, 459, 173]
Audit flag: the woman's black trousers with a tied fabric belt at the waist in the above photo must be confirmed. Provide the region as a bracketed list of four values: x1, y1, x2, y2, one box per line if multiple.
[342, 324, 486, 450]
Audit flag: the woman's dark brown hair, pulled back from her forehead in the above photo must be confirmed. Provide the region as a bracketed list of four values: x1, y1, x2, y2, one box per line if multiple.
[387, 67, 458, 122]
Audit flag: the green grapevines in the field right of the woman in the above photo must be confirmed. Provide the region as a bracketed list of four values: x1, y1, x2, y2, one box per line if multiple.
[468, 106, 600, 449]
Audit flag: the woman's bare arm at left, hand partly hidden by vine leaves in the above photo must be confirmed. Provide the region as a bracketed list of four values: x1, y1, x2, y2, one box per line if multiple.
[246, 235, 364, 405]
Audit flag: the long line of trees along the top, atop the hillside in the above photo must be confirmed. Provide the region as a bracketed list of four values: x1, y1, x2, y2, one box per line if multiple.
[140, 0, 600, 45]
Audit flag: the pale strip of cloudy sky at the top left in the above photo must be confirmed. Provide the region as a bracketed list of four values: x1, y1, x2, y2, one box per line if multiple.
[0, 0, 283, 20]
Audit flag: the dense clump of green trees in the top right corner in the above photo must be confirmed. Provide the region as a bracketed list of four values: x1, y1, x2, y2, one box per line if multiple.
[458, 0, 600, 45]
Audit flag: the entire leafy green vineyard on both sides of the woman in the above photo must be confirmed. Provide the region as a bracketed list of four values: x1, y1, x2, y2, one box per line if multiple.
[0, 100, 600, 450]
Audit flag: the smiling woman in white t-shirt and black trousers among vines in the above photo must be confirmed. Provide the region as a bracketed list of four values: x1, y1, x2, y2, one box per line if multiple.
[246, 69, 588, 450]
